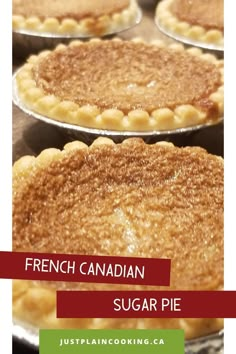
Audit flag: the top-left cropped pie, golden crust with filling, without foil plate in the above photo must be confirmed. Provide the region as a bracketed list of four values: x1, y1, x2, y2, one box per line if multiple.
[12, 0, 139, 36]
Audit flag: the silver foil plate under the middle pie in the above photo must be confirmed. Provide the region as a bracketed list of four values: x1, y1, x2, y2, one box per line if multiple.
[13, 73, 223, 144]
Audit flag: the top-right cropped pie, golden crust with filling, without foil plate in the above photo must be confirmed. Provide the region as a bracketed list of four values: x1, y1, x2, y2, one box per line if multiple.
[156, 0, 224, 48]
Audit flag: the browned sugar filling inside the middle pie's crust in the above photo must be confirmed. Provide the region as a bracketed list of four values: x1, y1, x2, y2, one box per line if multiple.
[33, 41, 221, 117]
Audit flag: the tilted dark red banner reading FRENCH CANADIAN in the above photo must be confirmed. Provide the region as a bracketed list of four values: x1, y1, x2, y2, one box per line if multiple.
[0, 252, 171, 286]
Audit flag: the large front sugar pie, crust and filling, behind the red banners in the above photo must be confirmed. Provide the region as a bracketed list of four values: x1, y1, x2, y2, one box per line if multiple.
[13, 138, 224, 339]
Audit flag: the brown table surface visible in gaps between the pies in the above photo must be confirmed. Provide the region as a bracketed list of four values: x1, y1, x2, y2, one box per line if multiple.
[13, 0, 223, 354]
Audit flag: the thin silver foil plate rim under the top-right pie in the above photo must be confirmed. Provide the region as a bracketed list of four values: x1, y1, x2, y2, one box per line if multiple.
[155, 16, 224, 55]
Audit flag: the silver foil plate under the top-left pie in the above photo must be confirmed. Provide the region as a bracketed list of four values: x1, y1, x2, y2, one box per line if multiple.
[12, 8, 142, 56]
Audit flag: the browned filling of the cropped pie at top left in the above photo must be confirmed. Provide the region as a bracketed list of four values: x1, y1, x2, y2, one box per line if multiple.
[13, 0, 130, 21]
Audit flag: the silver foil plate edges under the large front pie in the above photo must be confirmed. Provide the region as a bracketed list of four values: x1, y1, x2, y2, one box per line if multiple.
[13, 321, 224, 354]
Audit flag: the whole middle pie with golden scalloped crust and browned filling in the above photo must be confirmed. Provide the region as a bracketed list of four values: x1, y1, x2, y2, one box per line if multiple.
[16, 39, 224, 131]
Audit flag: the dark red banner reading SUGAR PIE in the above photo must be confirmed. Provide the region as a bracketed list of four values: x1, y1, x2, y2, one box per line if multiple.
[57, 291, 236, 318]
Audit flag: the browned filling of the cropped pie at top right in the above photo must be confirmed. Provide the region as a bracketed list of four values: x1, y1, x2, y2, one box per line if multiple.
[171, 0, 224, 31]
